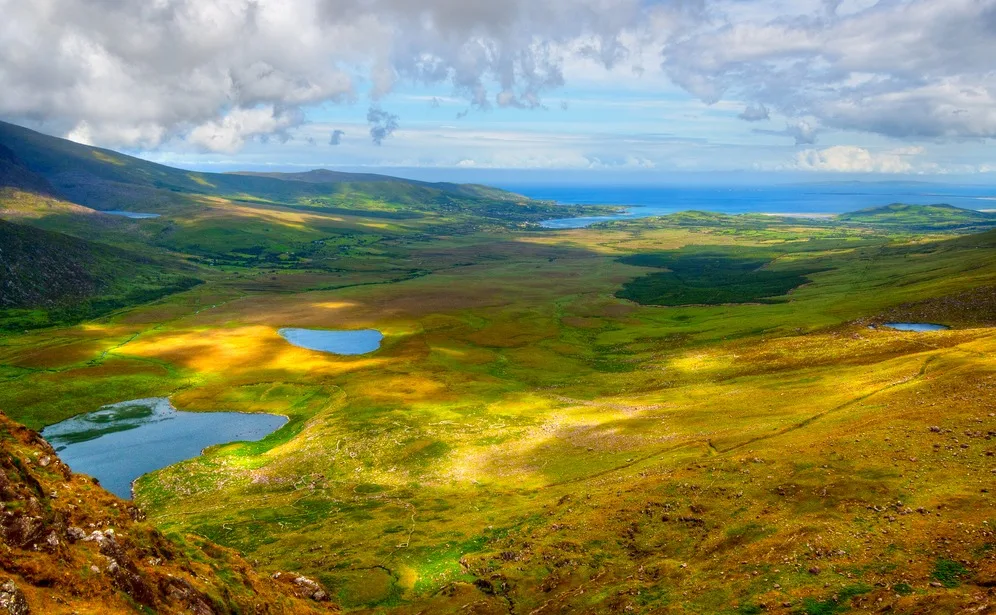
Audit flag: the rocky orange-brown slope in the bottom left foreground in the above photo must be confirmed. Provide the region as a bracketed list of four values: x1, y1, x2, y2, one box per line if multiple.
[0, 412, 336, 615]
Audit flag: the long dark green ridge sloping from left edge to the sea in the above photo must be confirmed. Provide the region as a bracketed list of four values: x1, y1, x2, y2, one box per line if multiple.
[0, 122, 590, 225]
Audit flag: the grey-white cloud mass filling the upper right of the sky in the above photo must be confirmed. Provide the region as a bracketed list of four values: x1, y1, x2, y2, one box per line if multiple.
[662, 0, 996, 139]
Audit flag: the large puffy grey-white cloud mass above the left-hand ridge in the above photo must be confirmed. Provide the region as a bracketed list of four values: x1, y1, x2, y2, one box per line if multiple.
[0, 0, 692, 151]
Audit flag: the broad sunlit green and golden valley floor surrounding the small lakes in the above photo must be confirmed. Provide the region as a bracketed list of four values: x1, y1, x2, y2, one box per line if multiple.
[0, 125, 996, 615]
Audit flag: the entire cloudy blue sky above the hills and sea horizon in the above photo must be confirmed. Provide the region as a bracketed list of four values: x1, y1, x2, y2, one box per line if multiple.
[0, 0, 996, 182]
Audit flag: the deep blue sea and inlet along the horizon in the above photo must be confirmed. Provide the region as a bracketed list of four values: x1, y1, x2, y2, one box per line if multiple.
[501, 182, 996, 228]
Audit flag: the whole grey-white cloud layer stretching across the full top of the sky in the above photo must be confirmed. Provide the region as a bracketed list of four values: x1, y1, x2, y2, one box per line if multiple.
[0, 0, 996, 156]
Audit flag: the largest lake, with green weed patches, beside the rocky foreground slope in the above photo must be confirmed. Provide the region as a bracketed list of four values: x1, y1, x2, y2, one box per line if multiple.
[41, 397, 287, 500]
